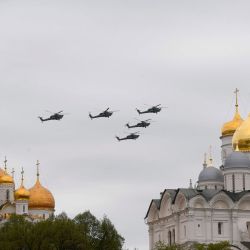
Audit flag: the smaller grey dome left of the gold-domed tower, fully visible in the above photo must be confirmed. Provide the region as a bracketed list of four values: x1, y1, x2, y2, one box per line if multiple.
[198, 166, 224, 183]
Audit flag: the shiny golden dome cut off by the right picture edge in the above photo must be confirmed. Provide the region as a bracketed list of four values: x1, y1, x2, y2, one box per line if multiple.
[232, 114, 250, 152]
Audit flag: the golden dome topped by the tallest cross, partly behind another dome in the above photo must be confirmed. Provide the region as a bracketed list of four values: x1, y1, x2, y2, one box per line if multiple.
[221, 89, 244, 136]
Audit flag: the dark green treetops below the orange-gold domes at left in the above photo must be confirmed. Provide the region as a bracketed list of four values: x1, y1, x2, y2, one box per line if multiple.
[0, 211, 124, 250]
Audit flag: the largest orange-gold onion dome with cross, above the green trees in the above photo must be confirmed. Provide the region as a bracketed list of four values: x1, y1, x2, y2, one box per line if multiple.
[29, 161, 55, 210]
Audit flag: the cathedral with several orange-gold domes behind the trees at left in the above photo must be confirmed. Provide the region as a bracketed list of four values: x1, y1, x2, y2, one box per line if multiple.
[0, 159, 55, 224]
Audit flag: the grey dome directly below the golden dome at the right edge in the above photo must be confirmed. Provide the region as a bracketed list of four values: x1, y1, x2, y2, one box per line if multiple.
[224, 151, 250, 169]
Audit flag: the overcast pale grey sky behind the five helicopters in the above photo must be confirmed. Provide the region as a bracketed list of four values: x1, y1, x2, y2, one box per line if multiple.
[0, 0, 250, 250]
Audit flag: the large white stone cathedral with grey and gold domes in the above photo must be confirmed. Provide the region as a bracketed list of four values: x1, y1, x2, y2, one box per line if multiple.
[145, 89, 250, 250]
